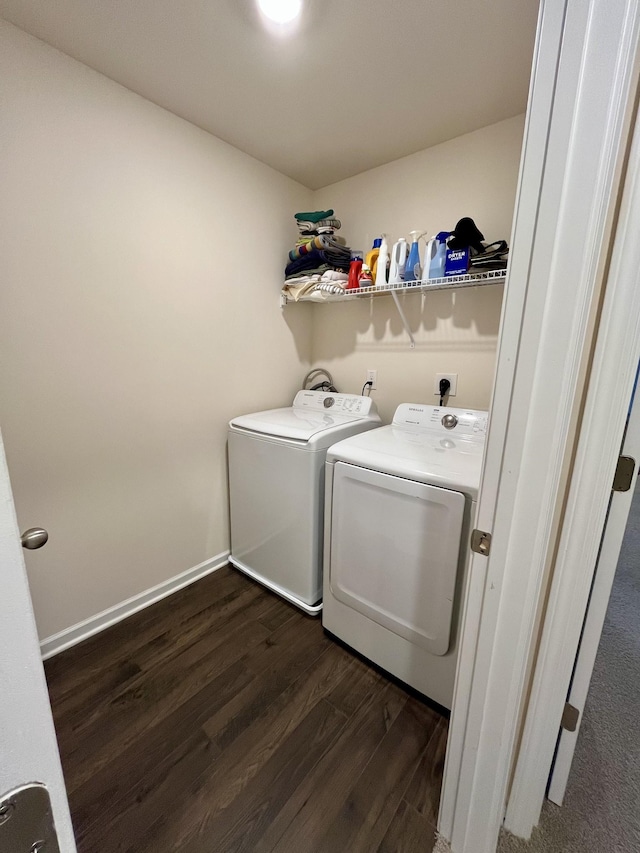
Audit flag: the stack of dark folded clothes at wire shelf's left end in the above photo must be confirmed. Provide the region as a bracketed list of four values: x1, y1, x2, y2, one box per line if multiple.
[284, 210, 351, 281]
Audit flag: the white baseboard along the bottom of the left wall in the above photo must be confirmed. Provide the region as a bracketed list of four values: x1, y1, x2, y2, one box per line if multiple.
[40, 551, 229, 660]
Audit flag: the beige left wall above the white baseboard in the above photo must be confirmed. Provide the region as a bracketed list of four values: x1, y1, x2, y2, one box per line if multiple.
[0, 22, 312, 637]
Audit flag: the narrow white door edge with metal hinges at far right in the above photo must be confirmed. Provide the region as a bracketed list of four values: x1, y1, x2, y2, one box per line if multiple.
[547, 368, 640, 806]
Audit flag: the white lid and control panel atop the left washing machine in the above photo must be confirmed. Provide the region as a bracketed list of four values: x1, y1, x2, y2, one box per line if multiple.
[229, 391, 380, 444]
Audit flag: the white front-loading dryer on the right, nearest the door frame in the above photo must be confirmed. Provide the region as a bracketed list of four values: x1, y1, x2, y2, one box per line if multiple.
[322, 403, 488, 708]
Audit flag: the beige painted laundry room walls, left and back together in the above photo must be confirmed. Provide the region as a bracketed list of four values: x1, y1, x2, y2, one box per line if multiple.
[0, 16, 523, 638]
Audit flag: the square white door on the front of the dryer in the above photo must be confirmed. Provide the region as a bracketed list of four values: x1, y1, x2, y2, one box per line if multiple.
[329, 462, 465, 655]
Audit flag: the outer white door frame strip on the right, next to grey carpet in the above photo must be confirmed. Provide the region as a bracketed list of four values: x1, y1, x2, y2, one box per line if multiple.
[505, 48, 640, 837]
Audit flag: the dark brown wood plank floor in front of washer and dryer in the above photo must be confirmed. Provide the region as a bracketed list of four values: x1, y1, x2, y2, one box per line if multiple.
[46, 568, 447, 853]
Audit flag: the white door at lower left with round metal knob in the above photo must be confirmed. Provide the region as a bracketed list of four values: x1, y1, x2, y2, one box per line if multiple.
[0, 436, 76, 853]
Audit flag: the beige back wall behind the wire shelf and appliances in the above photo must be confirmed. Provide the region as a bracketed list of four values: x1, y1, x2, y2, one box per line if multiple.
[310, 116, 524, 420]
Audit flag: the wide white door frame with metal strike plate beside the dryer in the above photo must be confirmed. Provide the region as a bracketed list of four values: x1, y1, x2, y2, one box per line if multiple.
[438, 0, 640, 853]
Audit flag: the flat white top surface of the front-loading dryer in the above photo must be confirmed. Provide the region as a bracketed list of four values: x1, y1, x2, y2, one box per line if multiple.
[327, 424, 484, 498]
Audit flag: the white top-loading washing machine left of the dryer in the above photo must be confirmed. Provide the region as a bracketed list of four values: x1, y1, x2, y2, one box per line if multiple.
[229, 391, 380, 615]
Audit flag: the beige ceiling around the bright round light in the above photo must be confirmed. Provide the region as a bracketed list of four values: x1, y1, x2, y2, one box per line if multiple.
[0, 0, 538, 189]
